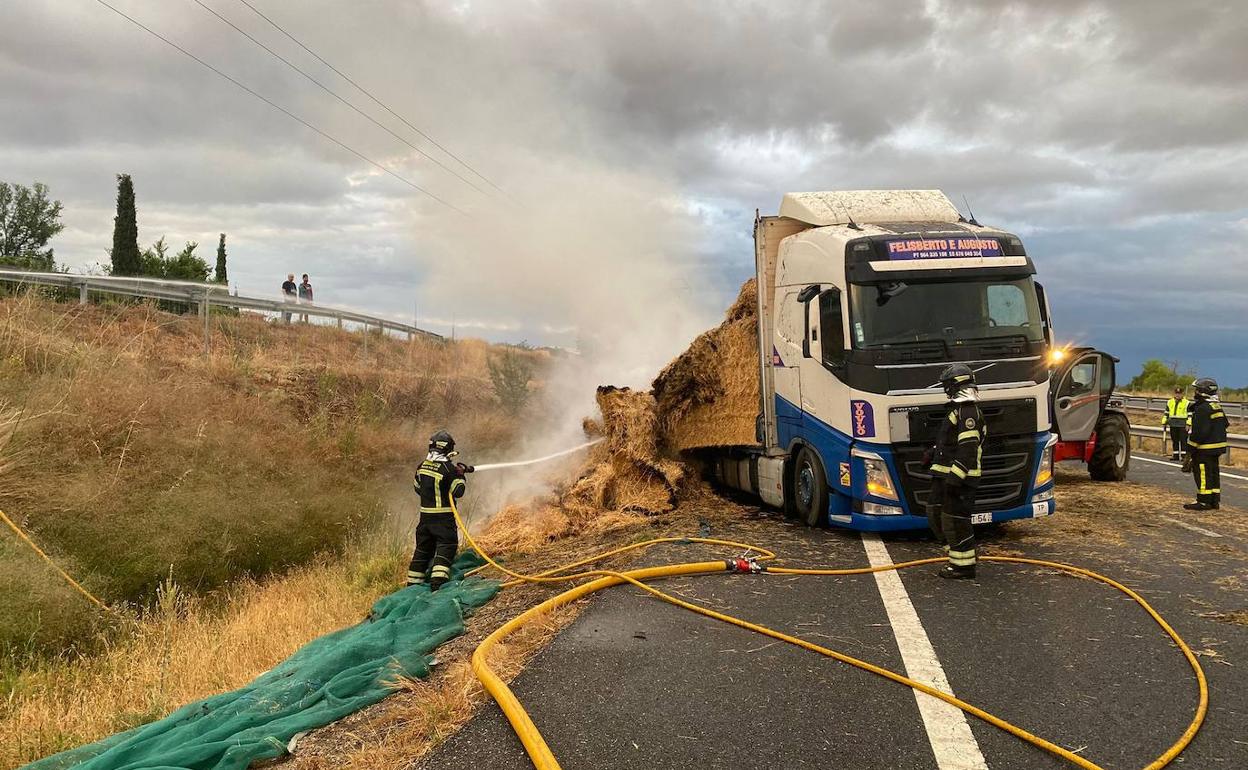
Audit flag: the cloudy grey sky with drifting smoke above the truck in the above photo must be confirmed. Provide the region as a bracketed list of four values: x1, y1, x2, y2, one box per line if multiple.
[0, 0, 1248, 387]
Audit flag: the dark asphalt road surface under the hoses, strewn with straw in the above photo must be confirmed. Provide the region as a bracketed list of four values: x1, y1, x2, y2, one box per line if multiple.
[421, 462, 1248, 770]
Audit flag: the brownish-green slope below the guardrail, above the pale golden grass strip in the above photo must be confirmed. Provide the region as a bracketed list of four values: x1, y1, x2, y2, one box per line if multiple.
[0, 295, 544, 658]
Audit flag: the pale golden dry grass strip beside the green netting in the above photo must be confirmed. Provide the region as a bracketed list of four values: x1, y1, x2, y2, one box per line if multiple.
[0, 542, 402, 768]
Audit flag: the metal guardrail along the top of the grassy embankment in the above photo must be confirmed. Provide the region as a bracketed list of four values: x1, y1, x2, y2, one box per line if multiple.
[0, 270, 443, 339]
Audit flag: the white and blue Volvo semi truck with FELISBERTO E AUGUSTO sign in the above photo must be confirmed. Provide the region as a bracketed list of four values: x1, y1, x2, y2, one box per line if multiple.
[709, 190, 1058, 532]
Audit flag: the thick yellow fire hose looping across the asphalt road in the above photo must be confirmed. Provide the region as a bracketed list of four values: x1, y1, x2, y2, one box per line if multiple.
[452, 502, 1209, 770]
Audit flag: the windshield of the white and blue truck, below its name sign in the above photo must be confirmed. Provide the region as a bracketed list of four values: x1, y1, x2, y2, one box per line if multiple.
[850, 277, 1043, 348]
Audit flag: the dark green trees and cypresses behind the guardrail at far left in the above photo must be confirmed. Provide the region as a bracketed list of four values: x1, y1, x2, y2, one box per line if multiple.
[0, 173, 228, 283]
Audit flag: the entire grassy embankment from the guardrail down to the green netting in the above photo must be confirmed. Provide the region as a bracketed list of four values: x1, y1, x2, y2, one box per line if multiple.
[0, 297, 543, 766]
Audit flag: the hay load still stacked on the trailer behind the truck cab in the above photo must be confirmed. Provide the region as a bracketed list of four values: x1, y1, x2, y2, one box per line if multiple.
[651, 278, 759, 452]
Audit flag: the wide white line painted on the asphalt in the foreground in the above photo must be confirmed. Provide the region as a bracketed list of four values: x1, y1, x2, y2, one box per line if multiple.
[862, 532, 988, 770]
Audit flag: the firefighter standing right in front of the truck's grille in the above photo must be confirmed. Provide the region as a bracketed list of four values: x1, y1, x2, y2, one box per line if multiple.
[925, 363, 987, 579]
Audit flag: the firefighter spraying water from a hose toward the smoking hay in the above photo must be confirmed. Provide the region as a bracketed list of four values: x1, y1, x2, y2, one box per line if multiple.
[407, 431, 475, 590]
